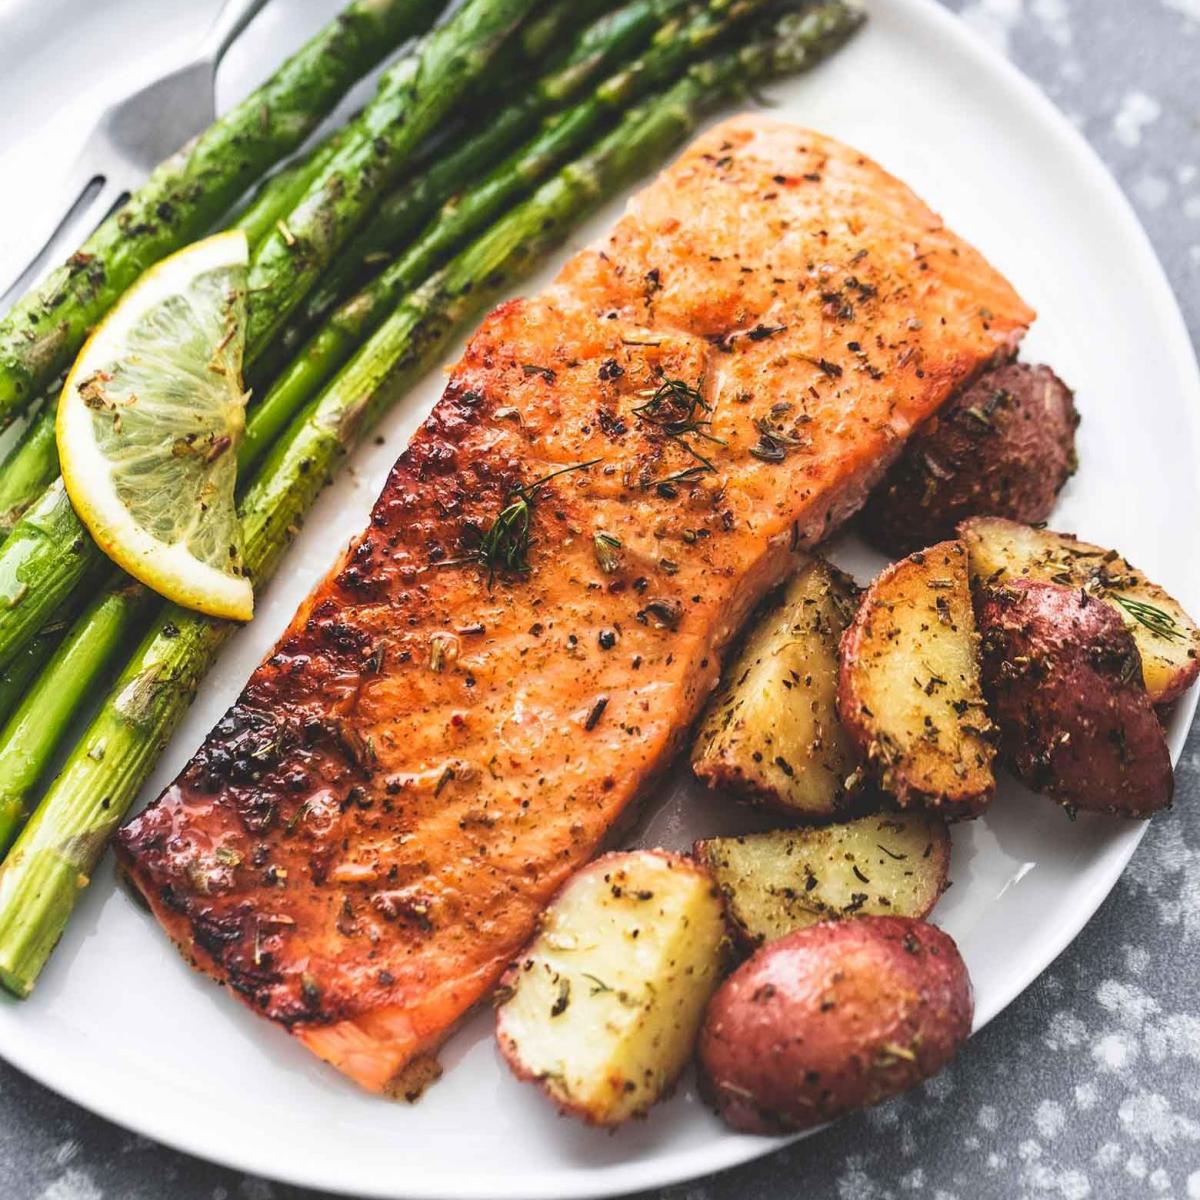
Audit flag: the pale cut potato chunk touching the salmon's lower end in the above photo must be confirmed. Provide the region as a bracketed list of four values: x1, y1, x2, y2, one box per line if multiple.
[496, 850, 726, 1126]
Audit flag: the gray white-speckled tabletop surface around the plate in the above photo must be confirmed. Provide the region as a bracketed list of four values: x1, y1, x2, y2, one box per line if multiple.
[0, 0, 1200, 1200]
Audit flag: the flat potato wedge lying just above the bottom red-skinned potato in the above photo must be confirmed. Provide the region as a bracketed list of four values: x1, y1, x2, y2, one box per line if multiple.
[692, 812, 950, 947]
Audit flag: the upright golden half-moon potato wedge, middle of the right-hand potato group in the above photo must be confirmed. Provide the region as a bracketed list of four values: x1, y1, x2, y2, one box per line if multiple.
[838, 541, 995, 816]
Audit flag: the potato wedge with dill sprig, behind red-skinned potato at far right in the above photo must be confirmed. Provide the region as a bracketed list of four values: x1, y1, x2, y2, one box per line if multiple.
[959, 517, 1200, 704]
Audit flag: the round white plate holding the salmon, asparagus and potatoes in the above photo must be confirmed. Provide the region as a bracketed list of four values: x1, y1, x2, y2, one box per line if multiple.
[0, 0, 1200, 1200]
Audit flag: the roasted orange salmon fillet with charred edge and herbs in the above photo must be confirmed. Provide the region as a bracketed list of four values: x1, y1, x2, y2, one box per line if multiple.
[118, 115, 1033, 1093]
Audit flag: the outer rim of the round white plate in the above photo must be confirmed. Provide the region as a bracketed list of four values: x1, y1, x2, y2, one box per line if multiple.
[0, 0, 1200, 1200]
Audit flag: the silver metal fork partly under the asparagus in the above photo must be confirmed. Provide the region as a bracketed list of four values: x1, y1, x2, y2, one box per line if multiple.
[0, 0, 266, 311]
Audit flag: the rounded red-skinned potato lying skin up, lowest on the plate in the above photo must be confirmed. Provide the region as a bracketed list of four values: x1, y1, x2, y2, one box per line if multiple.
[698, 917, 974, 1134]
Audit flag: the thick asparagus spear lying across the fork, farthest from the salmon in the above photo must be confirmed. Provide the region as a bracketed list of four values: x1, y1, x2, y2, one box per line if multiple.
[0, 0, 436, 427]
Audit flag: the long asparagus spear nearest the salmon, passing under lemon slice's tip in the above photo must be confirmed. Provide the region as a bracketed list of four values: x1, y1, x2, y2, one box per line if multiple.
[0, 2, 859, 996]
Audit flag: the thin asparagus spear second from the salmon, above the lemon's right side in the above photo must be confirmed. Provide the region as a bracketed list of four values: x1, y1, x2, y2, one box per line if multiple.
[239, 0, 734, 467]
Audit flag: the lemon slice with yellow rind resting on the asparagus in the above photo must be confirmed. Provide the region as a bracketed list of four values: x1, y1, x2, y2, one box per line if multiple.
[56, 230, 254, 620]
